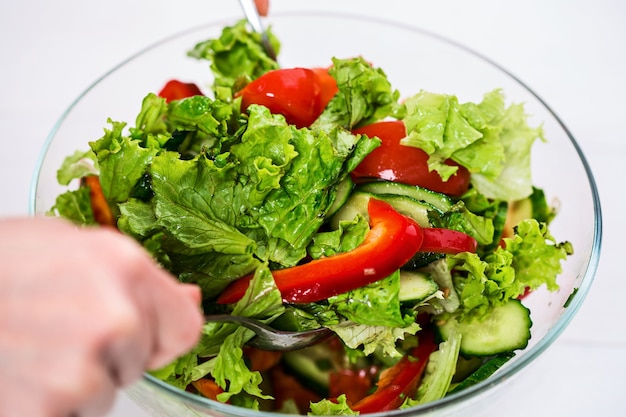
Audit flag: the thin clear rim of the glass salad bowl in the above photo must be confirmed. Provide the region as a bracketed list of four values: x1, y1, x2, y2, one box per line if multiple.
[28, 10, 602, 417]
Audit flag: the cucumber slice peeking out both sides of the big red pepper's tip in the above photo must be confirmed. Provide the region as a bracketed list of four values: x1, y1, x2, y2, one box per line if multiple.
[330, 191, 436, 229]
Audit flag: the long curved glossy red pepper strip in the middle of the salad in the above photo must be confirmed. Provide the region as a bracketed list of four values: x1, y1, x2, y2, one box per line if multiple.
[217, 198, 423, 304]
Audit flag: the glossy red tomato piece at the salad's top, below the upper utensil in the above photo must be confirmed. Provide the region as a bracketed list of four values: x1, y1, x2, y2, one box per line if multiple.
[237, 68, 337, 128]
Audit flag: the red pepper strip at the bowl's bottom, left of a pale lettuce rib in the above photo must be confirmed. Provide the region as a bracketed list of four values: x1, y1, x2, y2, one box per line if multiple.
[350, 329, 437, 414]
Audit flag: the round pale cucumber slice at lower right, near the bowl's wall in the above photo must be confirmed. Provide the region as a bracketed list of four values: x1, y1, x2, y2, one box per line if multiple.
[439, 300, 532, 356]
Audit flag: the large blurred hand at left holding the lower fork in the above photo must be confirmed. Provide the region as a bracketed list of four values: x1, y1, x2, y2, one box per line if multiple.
[0, 218, 203, 417]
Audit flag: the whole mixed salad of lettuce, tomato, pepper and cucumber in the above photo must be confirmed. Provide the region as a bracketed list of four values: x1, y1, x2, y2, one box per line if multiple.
[36, 14, 575, 415]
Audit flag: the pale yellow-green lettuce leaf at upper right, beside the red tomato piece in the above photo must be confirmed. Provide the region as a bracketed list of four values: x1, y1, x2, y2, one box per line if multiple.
[402, 90, 543, 201]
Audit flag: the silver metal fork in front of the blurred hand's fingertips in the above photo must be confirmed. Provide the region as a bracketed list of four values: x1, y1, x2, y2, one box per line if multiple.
[204, 314, 332, 351]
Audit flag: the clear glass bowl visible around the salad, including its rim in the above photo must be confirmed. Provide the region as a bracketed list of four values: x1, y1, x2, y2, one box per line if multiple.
[30, 8, 601, 417]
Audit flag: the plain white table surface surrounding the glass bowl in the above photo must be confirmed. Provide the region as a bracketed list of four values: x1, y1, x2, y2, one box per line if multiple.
[0, 0, 626, 417]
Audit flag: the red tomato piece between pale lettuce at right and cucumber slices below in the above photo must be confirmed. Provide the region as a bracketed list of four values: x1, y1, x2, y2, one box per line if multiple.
[352, 120, 470, 196]
